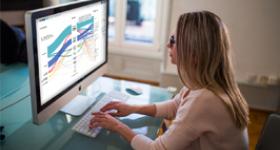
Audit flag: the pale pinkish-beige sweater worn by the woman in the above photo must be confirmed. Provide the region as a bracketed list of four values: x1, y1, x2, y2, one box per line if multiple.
[131, 88, 248, 150]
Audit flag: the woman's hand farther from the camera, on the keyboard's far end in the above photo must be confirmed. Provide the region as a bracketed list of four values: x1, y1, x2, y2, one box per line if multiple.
[101, 101, 135, 117]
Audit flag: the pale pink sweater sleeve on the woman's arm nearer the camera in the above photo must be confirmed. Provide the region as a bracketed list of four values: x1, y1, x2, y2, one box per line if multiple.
[131, 89, 221, 150]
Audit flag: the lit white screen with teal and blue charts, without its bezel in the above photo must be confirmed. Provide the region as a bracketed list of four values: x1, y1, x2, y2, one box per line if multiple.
[36, 2, 106, 105]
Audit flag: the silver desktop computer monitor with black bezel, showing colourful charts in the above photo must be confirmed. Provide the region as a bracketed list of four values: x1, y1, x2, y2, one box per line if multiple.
[25, 0, 108, 124]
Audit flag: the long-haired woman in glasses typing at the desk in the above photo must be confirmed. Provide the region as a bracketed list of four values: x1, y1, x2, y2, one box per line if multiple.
[89, 11, 249, 150]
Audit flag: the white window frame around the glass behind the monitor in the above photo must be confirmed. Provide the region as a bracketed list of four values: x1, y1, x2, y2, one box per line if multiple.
[108, 0, 170, 60]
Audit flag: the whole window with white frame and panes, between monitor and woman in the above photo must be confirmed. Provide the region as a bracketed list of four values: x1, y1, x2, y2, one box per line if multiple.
[109, 0, 169, 57]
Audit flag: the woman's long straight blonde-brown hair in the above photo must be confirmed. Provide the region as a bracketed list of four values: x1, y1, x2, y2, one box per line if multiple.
[176, 11, 249, 129]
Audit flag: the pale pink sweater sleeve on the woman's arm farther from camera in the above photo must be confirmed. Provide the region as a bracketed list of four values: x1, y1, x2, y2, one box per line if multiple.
[155, 88, 185, 119]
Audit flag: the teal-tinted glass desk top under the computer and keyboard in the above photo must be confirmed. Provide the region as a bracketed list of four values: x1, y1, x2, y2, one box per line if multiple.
[0, 64, 173, 150]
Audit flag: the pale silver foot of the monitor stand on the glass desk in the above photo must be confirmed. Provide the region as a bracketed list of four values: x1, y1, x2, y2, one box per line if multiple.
[60, 95, 96, 116]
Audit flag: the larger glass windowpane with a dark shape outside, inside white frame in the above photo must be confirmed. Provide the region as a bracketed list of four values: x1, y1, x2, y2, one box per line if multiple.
[124, 0, 157, 44]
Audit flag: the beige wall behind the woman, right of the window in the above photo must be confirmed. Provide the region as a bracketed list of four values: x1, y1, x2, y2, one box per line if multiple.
[161, 0, 280, 110]
